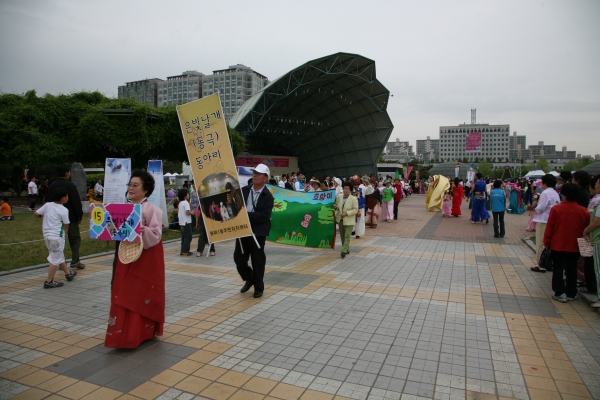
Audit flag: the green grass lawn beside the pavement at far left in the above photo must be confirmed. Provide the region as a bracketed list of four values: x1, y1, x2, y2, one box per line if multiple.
[0, 213, 181, 271]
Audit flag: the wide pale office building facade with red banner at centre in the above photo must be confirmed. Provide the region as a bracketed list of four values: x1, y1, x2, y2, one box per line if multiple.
[439, 123, 510, 162]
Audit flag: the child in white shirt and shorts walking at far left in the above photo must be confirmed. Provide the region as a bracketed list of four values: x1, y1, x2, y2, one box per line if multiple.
[34, 187, 77, 289]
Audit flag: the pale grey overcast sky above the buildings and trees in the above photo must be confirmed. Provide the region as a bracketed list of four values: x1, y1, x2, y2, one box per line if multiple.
[0, 0, 600, 155]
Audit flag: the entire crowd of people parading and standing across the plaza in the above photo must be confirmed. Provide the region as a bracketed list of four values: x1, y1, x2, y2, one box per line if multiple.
[21, 164, 600, 348]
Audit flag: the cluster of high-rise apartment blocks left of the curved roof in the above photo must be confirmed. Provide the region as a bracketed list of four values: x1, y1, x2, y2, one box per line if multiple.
[118, 64, 269, 121]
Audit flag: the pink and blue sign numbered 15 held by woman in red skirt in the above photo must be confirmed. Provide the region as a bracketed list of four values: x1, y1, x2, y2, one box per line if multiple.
[90, 203, 142, 242]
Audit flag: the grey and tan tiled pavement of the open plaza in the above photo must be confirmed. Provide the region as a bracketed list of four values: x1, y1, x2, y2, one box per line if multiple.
[0, 196, 600, 400]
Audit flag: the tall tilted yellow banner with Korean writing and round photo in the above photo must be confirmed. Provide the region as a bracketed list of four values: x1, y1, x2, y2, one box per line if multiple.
[177, 93, 252, 243]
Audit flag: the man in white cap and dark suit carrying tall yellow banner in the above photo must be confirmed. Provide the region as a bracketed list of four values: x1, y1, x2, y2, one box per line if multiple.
[233, 164, 274, 298]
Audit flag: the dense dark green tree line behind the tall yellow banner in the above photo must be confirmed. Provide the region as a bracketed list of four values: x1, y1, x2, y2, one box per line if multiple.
[0, 90, 245, 188]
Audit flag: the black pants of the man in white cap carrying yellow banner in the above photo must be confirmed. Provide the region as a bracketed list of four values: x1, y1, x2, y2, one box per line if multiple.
[233, 236, 267, 293]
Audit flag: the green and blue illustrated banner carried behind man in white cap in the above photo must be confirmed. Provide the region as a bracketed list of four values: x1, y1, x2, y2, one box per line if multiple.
[267, 185, 335, 249]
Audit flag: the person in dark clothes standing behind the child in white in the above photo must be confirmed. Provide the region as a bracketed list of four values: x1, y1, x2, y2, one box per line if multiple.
[48, 165, 85, 269]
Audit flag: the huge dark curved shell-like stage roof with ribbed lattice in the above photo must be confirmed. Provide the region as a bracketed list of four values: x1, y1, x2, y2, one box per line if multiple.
[229, 53, 394, 176]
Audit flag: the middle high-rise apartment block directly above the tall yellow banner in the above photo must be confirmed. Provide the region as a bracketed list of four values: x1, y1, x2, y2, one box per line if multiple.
[158, 71, 204, 107]
